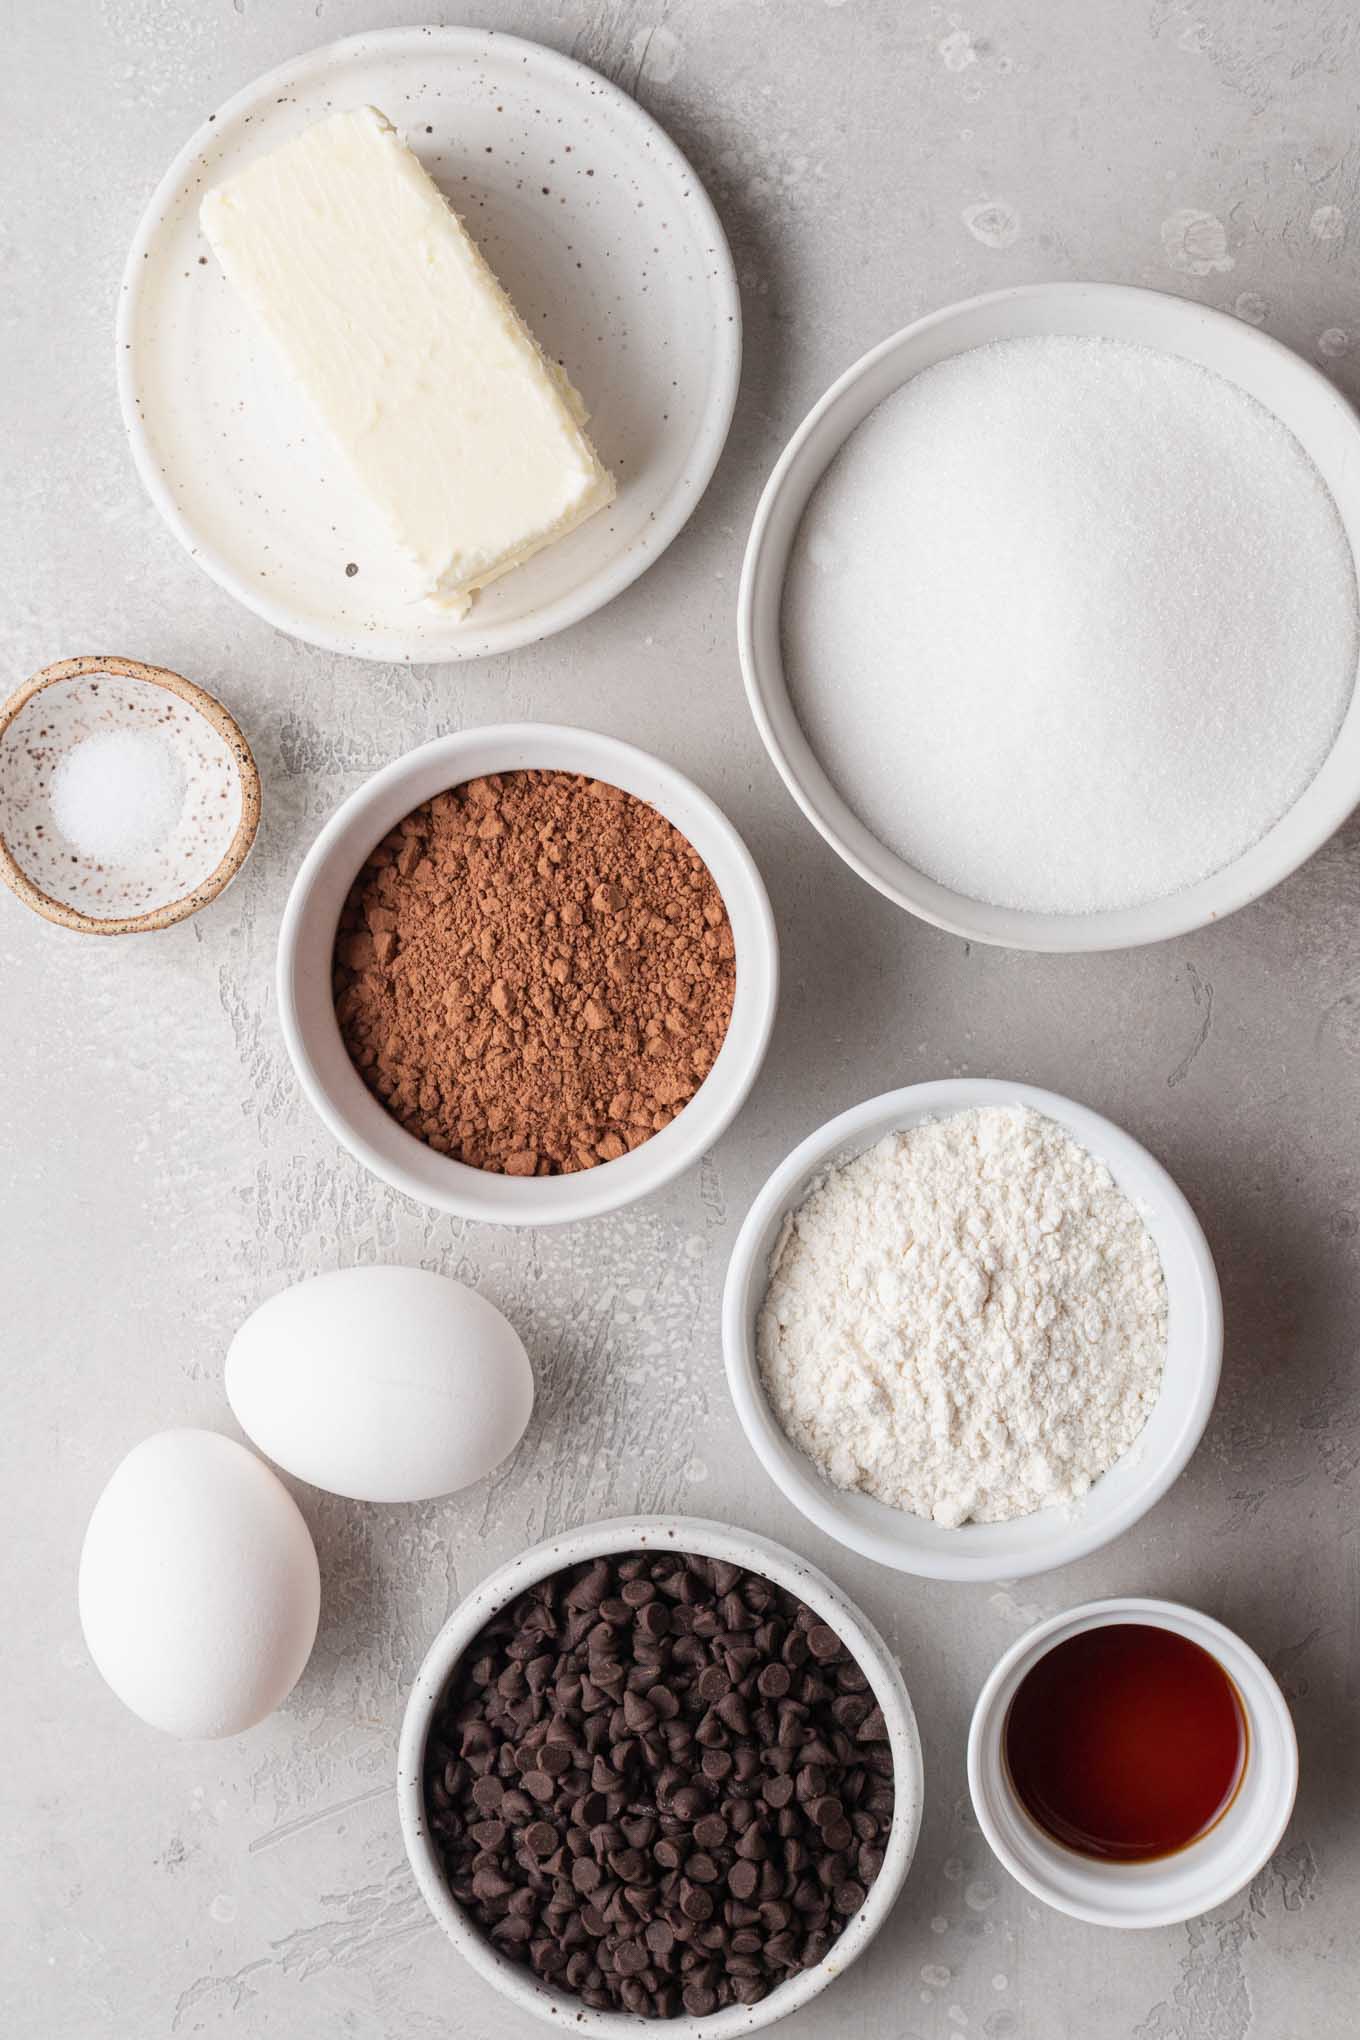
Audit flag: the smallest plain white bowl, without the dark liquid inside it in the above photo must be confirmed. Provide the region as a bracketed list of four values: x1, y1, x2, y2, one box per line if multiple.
[969, 1599, 1299, 1926]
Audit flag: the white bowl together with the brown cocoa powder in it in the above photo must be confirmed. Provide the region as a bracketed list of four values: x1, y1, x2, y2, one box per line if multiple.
[277, 724, 779, 1226]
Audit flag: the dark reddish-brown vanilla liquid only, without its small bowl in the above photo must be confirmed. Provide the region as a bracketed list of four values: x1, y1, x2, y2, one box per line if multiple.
[1003, 1622, 1248, 1863]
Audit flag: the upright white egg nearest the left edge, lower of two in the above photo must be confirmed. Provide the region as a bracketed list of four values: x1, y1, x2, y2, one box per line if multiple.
[80, 1430, 320, 1736]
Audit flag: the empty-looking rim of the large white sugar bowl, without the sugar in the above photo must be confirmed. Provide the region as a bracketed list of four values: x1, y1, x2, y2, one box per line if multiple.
[738, 284, 1360, 951]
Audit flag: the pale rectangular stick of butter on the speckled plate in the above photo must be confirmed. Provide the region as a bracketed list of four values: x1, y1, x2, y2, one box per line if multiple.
[200, 106, 614, 614]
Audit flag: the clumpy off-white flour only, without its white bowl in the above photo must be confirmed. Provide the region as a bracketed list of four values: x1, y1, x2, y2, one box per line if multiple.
[756, 1106, 1166, 1524]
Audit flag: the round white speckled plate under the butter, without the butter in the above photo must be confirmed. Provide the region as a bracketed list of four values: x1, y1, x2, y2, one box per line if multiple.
[118, 29, 740, 661]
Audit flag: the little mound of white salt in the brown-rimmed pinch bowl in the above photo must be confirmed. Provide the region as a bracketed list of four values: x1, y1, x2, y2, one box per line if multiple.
[51, 730, 186, 865]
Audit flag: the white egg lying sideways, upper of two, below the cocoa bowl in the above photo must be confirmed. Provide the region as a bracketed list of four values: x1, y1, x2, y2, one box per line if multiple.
[226, 1269, 534, 1501]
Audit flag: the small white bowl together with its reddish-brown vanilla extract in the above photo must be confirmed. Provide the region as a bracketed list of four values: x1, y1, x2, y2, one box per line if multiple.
[969, 1599, 1299, 1928]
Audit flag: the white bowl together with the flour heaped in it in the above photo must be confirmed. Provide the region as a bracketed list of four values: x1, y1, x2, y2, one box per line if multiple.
[722, 1077, 1223, 1581]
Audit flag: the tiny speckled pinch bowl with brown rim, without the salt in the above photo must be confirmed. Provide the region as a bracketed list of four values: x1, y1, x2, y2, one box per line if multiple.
[0, 657, 259, 934]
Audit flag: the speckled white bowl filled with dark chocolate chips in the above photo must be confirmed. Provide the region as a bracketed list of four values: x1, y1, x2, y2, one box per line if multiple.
[398, 1516, 924, 2040]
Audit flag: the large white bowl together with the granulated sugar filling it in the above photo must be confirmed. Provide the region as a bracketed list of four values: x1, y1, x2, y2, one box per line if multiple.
[740, 284, 1360, 951]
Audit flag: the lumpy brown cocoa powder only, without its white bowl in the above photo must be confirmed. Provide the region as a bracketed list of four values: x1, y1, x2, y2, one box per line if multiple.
[334, 771, 736, 1175]
